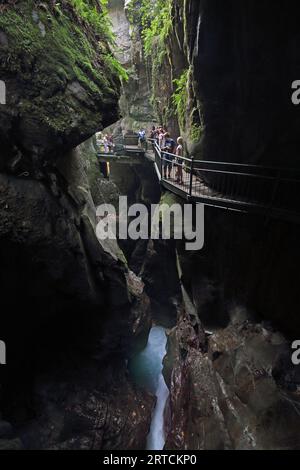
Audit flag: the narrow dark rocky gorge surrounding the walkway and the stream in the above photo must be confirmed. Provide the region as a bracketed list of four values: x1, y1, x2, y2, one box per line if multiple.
[0, 0, 300, 451]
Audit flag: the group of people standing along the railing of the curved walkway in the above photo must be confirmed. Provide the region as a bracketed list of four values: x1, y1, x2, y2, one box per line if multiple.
[150, 126, 183, 185]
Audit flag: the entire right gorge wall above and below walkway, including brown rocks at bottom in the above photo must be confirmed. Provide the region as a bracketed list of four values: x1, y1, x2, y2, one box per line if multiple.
[137, 0, 300, 449]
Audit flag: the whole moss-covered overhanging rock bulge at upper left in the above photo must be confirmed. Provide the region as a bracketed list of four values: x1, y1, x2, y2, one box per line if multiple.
[0, 0, 120, 162]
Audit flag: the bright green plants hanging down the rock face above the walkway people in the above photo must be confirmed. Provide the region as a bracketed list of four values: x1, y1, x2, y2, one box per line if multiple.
[127, 0, 204, 142]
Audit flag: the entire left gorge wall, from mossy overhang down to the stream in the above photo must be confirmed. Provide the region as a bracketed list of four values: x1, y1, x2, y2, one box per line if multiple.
[0, 0, 153, 449]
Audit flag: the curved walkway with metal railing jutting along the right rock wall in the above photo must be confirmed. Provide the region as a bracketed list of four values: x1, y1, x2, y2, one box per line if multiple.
[151, 140, 300, 221]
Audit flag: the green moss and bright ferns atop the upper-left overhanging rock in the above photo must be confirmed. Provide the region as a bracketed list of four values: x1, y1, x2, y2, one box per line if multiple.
[0, 0, 128, 96]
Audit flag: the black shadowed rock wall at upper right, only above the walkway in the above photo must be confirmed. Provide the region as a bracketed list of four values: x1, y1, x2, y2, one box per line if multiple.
[169, 0, 299, 163]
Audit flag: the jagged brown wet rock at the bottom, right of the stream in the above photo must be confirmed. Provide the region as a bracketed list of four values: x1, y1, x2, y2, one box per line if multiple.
[166, 308, 300, 450]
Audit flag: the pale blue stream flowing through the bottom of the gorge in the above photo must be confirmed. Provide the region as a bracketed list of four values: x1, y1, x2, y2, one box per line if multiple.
[130, 326, 169, 450]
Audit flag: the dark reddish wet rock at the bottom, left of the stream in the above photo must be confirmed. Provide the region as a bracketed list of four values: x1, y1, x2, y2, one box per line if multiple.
[18, 360, 154, 450]
